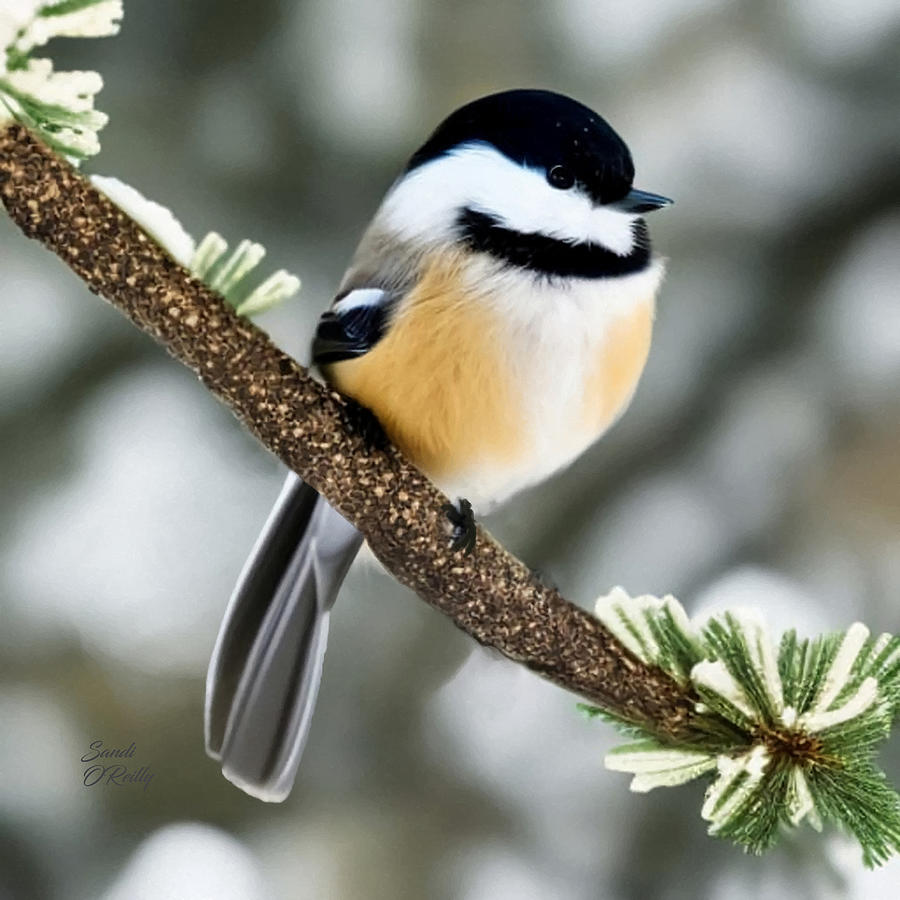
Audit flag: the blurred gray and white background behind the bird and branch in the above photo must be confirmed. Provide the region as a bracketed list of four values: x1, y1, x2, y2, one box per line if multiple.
[0, 0, 900, 900]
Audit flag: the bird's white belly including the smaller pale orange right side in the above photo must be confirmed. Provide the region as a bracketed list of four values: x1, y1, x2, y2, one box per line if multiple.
[438, 262, 663, 512]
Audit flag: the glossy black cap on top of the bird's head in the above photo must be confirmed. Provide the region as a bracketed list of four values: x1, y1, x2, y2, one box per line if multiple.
[406, 90, 634, 203]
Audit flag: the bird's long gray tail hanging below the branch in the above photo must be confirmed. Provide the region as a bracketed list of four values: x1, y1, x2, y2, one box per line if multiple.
[205, 474, 362, 802]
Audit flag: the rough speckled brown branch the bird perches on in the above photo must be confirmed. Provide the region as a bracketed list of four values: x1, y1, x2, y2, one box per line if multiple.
[0, 125, 693, 740]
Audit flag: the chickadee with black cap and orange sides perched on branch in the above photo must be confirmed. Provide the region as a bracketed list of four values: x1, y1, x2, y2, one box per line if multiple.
[205, 90, 671, 801]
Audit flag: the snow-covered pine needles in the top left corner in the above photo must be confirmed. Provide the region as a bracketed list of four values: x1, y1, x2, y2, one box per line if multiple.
[0, 0, 122, 161]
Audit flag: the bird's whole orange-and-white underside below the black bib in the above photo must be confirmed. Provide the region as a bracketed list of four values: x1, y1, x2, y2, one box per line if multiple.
[325, 256, 657, 502]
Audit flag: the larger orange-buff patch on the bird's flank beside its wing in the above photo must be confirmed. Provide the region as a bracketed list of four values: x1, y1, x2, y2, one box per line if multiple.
[325, 253, 523, 478]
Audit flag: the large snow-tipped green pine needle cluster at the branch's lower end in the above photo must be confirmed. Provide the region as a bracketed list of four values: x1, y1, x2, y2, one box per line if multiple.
[588, 588, 900, 865]
